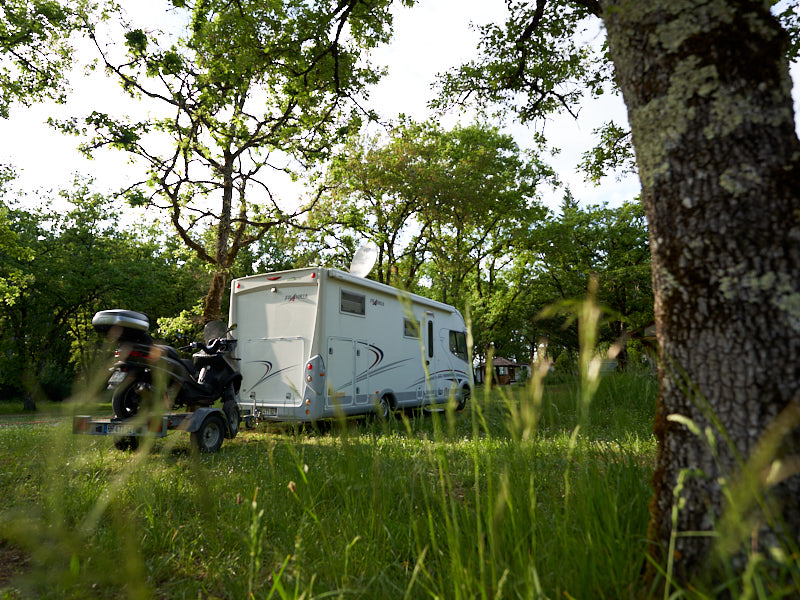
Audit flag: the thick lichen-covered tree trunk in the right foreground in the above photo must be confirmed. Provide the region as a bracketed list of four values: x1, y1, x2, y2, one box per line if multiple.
[601, 0, 800, 581]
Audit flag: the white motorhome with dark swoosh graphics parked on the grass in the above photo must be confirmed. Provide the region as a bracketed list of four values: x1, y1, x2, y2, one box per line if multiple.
[230, 267, 473, 421]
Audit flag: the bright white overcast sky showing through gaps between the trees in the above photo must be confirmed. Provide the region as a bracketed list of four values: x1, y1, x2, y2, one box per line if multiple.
[0, 0, 800, 216]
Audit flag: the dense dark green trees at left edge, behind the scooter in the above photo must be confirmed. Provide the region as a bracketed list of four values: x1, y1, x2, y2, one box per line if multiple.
[0, 182, 207, 399]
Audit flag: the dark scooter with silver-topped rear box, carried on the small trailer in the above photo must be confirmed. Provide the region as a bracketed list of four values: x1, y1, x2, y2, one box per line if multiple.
[92, 310, 242, 443]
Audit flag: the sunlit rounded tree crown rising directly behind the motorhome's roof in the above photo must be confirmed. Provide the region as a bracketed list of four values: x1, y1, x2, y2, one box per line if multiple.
[314, 121, 552, 300]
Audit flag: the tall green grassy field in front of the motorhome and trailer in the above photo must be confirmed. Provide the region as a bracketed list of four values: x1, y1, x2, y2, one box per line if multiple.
[0, 374, 656, 599]
